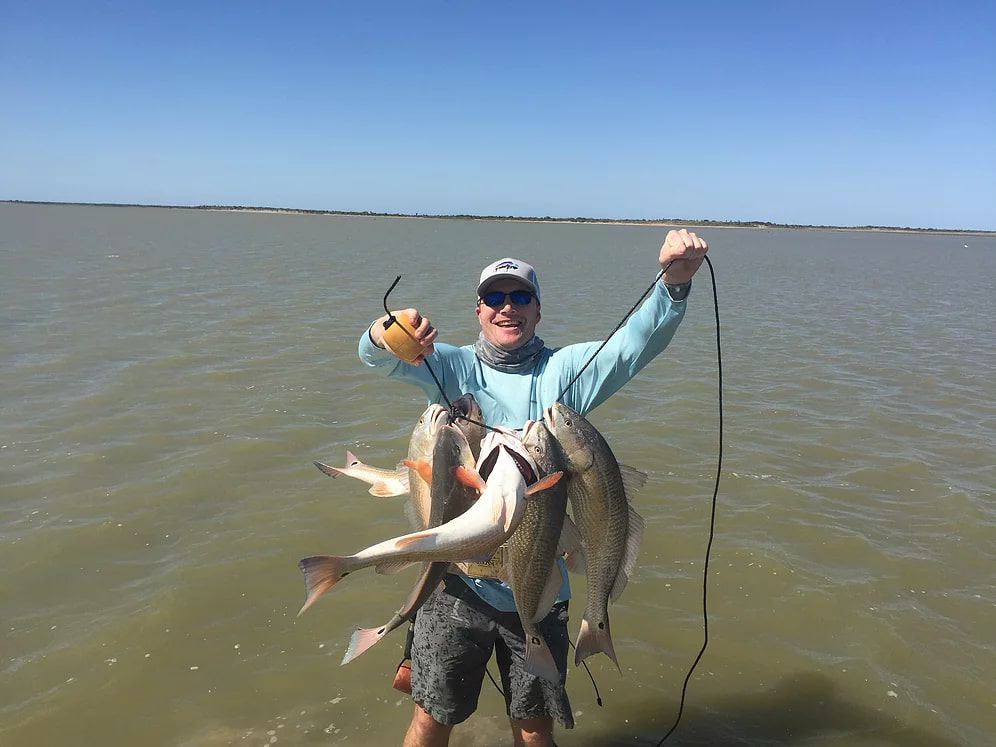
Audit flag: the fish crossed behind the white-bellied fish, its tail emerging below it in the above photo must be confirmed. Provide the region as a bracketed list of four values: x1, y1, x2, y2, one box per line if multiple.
[342, 425, 477, 664]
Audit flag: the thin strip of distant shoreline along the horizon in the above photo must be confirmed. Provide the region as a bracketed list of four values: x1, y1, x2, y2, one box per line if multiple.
[0, 200, 996, 236]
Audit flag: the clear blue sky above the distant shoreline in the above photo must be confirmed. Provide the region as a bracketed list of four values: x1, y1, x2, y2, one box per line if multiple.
[0, 0, 996, 230]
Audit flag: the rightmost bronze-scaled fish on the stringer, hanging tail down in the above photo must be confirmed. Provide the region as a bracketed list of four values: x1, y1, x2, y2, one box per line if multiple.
[543, 402, 647, 671]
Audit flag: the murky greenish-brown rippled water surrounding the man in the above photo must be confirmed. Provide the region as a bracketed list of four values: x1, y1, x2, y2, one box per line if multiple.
[0, 204, 996, 747]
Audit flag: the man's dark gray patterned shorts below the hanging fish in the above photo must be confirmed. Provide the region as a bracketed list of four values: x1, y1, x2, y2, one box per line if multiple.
[412, 575, 574, 729]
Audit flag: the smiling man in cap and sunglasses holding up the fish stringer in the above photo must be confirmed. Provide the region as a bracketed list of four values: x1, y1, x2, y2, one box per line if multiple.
[359, 229, 708, 747]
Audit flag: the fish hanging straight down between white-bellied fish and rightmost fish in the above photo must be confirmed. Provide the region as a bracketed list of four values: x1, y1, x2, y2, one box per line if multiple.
[503, 420, 567, 682]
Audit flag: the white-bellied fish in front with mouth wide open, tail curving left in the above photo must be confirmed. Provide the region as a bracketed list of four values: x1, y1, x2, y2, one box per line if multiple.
[298, 425, 563, 615]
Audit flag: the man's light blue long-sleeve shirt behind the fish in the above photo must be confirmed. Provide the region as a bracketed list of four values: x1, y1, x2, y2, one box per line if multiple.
[359, 282, 687, 612]
